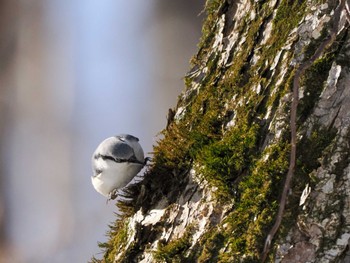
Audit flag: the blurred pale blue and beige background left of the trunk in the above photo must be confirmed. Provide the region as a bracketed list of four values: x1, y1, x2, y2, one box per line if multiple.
[0, 0, 204, 263]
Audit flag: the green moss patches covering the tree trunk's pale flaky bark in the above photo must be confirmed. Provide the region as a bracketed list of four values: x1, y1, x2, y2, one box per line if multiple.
[91, 0, 342, 262]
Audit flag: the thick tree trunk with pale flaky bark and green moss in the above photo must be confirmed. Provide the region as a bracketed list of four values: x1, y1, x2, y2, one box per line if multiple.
[93, 0, 350, 262]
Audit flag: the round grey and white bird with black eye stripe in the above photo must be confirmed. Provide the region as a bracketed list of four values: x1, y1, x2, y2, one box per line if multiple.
[91, 134, 150, 201]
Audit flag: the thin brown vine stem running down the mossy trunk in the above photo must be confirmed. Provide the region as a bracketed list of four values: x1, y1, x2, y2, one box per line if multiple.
[261, 0, 345, 262]
